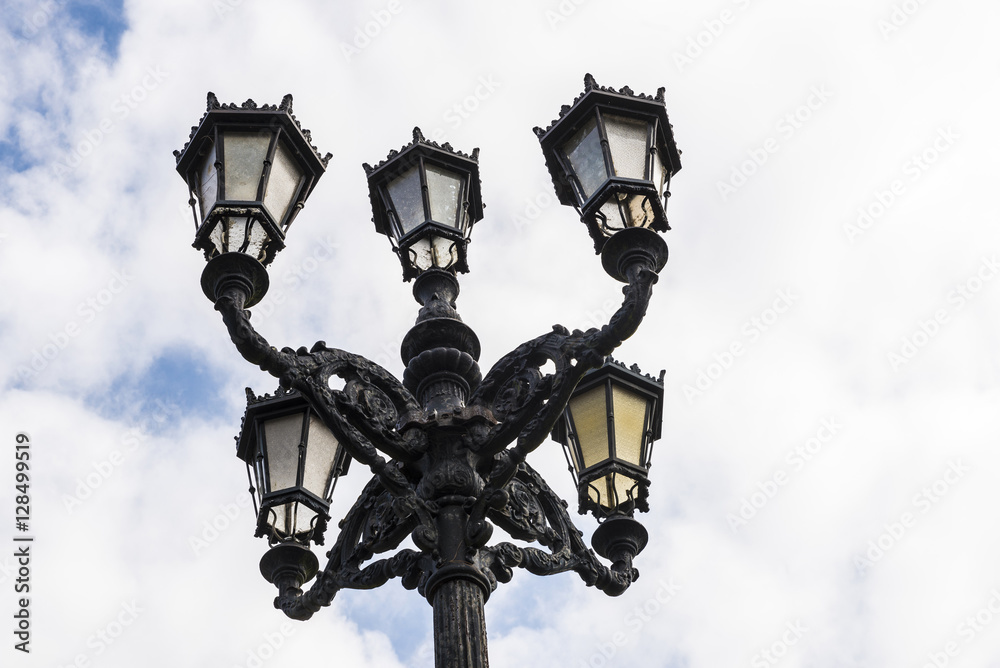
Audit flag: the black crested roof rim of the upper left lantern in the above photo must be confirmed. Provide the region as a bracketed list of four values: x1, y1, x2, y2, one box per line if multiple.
[174, 92, 333, 175]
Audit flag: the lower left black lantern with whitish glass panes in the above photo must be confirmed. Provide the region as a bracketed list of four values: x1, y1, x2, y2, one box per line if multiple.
[237, 388, 350, 545]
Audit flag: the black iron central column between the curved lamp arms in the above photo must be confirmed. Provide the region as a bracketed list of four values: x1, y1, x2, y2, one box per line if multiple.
[400, 269, 491, 668]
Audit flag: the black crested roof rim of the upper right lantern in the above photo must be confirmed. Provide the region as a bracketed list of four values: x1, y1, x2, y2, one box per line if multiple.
[534, 74, 681, 205]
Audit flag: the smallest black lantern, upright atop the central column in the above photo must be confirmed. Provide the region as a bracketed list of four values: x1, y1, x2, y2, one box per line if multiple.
[363, 128, 483, 281]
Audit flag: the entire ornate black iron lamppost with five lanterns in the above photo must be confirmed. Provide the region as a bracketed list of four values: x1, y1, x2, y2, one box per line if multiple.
[175, 74, 680, 668]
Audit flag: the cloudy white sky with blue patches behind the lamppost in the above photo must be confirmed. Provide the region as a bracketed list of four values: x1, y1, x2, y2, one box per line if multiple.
[0, 0, 1000, 668]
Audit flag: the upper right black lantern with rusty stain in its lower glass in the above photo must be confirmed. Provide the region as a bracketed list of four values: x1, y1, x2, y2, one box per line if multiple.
[535, 74, 681, 253]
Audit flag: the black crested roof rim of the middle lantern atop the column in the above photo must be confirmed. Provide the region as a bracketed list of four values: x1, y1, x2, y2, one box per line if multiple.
[361, 127, 485, 240]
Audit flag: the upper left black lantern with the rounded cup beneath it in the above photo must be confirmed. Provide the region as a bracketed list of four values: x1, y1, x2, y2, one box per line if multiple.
[174, 93, 331, 305]
